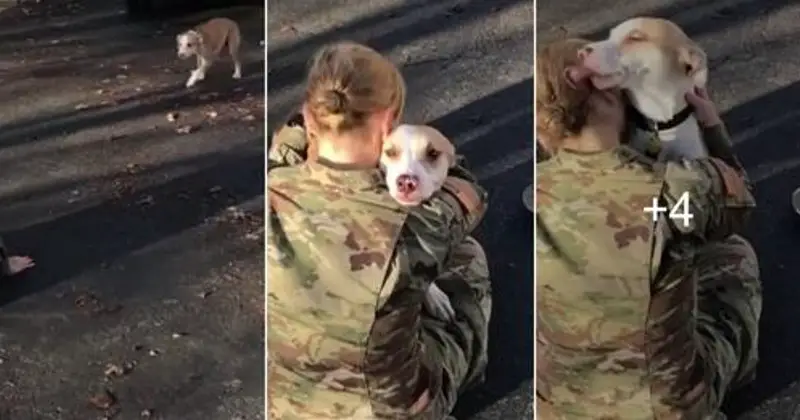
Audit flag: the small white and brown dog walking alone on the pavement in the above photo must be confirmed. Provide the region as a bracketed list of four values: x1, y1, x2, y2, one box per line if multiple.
[175, 18, 242, 87]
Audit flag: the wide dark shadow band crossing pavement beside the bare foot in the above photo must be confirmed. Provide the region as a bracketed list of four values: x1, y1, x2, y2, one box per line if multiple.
[0, 141, 265, 306]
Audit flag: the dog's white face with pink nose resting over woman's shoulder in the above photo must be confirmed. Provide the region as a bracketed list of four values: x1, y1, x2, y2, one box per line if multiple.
[381, 124, 455, 206]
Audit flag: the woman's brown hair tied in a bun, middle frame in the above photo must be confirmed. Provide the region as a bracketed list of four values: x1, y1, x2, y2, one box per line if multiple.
[303, 42, 406, 134]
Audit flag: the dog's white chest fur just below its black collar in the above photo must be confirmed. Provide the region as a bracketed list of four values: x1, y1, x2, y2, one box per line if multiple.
[630, 116, 708, 161]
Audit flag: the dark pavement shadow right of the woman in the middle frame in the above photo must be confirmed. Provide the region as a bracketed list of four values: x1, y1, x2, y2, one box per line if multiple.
[430, 79, 534, 418]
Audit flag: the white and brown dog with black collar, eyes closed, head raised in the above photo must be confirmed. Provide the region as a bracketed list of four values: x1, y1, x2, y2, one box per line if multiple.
[579, 17, 708, 160]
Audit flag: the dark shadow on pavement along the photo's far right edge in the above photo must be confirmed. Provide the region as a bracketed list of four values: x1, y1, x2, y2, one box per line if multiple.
[724, 82, 800, 416]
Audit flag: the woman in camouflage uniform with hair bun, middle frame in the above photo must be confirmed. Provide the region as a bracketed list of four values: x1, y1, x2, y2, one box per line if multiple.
[267, 43, 491, 420]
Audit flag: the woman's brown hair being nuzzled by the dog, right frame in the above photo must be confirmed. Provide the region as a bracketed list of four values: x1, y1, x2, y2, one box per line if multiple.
[535, 38, 591, 154]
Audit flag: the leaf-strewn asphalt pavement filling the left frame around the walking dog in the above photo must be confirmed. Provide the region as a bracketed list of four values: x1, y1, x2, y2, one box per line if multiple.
[0, 0, 264, 420]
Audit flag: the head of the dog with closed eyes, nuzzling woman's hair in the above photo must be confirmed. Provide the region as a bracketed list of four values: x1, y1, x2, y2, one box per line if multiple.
[579, 17, 708, 92]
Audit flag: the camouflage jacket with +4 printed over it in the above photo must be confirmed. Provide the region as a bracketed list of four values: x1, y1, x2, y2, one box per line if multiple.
[536, 146, 755, 420]
